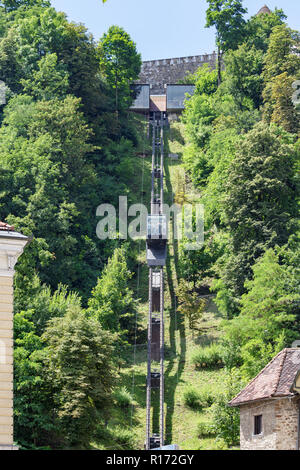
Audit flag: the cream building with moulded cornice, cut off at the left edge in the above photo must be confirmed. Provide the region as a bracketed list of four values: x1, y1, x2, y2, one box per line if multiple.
[0, 222, 28, 450]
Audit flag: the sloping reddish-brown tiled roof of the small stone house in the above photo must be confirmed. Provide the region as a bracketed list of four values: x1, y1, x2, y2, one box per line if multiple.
[229, 348, 300, 406]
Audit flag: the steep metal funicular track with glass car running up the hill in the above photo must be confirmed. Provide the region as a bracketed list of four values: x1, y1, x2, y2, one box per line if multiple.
[145, 112, 167, 450]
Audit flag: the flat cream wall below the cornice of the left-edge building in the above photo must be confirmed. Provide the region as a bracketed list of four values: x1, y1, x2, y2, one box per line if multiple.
[0, 276, 13, 446]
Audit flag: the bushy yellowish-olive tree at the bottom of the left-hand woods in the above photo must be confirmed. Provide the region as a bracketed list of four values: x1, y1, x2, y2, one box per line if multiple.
[43, 308, 115, 448]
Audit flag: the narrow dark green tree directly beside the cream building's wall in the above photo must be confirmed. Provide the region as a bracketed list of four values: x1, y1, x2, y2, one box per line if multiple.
[14, 310, 58, 449]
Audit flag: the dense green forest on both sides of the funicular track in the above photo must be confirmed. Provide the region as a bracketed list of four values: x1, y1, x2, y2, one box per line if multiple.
[0, 0, 300, 449]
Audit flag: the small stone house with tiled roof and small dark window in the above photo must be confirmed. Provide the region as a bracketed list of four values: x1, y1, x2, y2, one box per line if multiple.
[229, 348, 300, 450]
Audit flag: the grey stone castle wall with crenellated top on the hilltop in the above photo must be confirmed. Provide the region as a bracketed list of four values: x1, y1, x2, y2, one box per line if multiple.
[138, 53, 217, 95]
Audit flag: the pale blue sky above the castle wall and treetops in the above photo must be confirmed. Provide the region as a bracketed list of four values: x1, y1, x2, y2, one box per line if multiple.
[52, 0, 300, 60]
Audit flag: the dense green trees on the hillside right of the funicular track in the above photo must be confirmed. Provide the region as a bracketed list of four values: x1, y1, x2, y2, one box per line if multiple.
[177, 1, 300, 444]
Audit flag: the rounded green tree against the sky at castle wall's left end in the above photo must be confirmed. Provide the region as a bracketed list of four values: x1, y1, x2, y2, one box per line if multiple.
[98, 26, 141, 112]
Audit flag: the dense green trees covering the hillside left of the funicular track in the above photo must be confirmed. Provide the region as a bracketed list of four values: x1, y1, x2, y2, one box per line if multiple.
[0, 0, 140, 448]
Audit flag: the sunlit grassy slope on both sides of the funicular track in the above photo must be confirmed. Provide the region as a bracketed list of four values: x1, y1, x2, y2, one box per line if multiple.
[97, 115, 224, 450]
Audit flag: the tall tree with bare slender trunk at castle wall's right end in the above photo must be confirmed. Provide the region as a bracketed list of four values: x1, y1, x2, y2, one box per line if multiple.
[206, 0, 247, 84]
